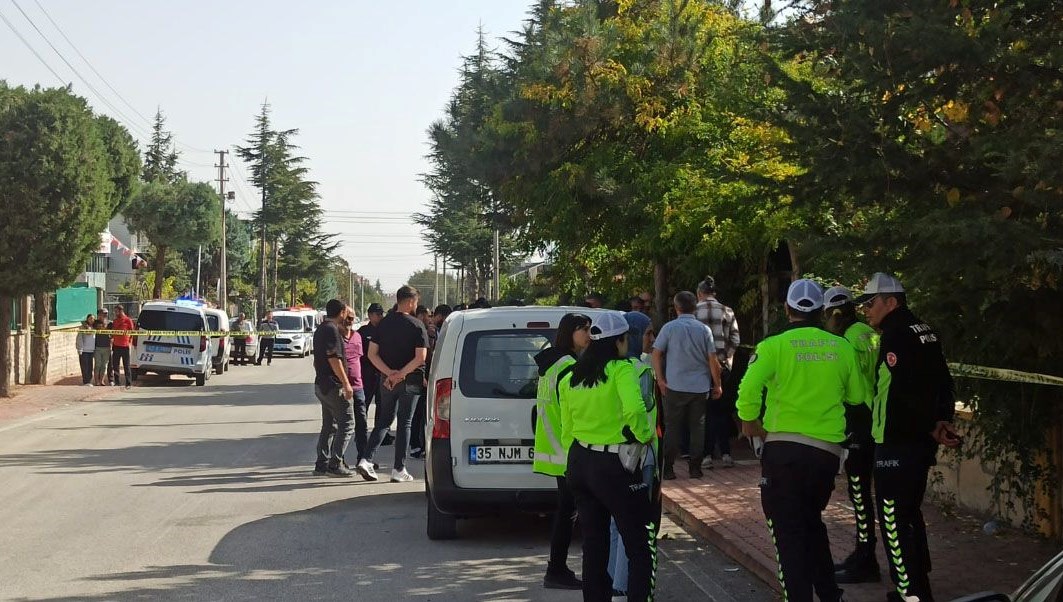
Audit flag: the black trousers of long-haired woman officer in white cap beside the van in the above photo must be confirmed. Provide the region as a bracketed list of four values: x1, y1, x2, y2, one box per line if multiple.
[568, 442, 658, 602]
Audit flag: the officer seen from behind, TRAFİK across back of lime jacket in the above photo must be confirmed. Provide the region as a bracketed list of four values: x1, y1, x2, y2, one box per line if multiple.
[738, 280, 868, 602]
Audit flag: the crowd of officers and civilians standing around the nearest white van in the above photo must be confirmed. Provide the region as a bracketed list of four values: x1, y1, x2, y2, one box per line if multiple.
[314, 273, 960, 602]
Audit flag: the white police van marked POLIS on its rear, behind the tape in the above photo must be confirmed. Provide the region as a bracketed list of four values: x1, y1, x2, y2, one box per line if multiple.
[130, 301, 214, 386]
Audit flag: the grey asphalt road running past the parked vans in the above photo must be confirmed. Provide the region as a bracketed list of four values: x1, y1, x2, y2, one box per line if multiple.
[0, 358, 776, 602]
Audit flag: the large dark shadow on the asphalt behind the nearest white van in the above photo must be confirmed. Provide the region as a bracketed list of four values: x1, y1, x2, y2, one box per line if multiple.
[18, 491, 565, 601]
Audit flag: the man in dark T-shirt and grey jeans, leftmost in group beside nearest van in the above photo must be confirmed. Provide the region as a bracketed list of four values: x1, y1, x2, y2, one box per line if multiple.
[314, 299, 354, 476]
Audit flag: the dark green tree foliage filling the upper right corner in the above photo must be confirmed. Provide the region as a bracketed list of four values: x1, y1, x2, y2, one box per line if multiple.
[774, 0, 1063, 527]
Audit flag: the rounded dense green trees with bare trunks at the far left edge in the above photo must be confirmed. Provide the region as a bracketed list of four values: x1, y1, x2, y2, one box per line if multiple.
[0, 83, 136, 389]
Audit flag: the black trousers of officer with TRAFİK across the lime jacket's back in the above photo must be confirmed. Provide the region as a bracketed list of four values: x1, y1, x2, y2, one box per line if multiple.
[760, 441, 842, 602]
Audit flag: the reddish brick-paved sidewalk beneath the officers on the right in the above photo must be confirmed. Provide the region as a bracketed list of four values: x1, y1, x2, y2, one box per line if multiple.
[664, 439, 1059, 602]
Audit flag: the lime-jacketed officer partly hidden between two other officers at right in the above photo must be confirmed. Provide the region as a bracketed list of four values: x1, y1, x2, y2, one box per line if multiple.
[823, 286, 882, 583]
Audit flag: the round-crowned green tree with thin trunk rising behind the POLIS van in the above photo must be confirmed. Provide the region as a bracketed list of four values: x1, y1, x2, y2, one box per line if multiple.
[124, 180, 221, 299]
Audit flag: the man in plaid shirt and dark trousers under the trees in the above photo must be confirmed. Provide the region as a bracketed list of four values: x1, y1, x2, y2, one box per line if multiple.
[694, 275, 741, 468]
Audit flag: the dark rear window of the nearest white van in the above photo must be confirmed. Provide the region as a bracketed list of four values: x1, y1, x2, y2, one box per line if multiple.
[458, 329, 554, 399]
